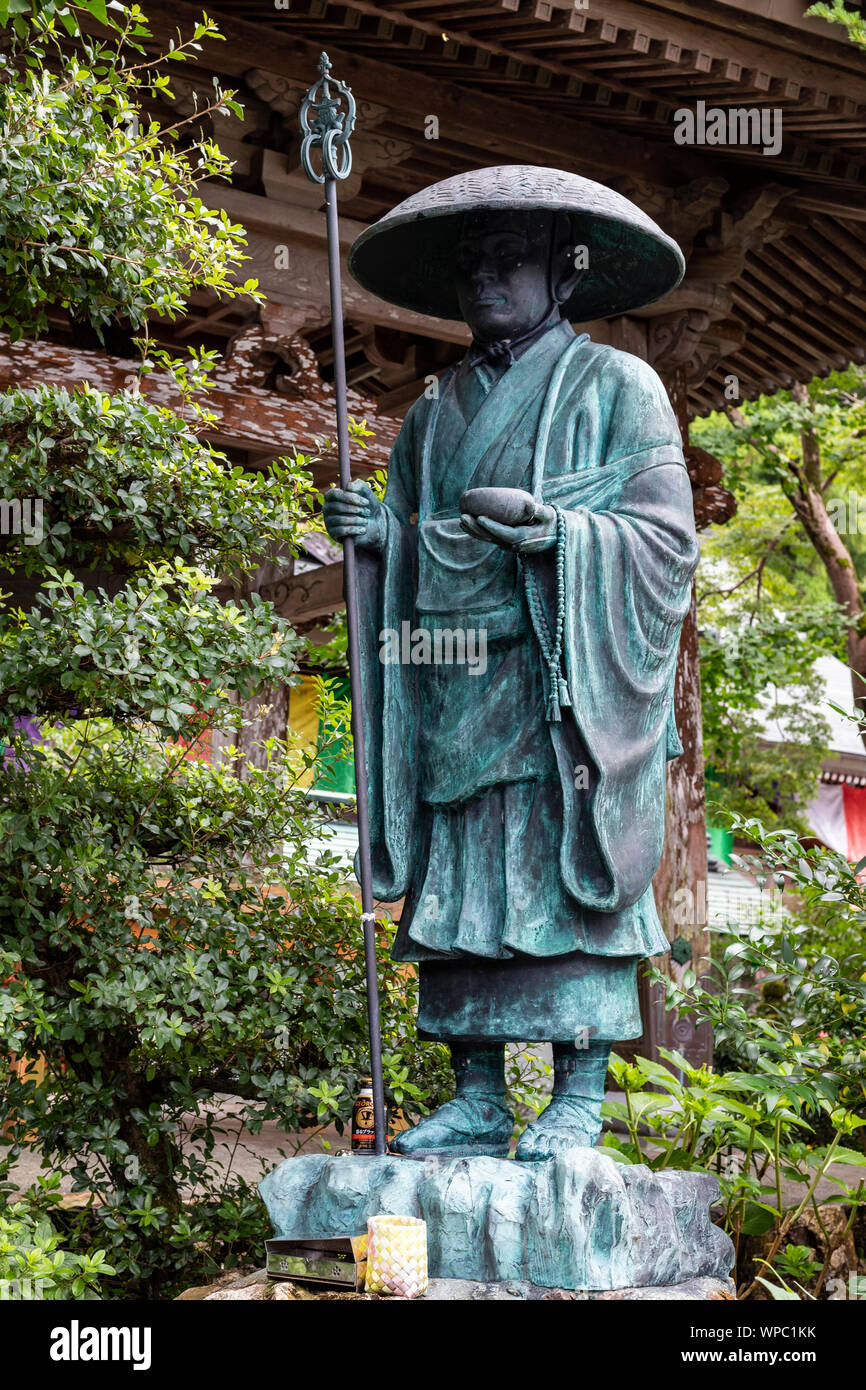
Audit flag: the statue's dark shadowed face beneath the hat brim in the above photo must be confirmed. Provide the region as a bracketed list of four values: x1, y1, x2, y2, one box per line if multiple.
[456, 213, 552, 342]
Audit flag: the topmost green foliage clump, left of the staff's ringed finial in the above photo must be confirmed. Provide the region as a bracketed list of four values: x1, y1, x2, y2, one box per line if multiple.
[0, 4, 257, 339]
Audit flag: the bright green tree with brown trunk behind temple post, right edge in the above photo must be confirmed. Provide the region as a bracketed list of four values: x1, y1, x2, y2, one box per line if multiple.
[694, 367, 866, 830]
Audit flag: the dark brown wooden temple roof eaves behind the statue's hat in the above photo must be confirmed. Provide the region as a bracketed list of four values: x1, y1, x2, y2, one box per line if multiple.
[127, 0, 866, 416]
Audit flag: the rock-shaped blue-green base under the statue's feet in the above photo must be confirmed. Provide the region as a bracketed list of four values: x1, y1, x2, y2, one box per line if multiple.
[260, 1148, 734, 1291]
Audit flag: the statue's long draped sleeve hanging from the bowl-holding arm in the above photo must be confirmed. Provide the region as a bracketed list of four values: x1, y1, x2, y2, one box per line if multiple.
[535, 350, 699, 912]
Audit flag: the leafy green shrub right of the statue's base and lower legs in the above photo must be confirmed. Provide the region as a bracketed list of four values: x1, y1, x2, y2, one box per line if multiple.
[605, 820, 866, 1297]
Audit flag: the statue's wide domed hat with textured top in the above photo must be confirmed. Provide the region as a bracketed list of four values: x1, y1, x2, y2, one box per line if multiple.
[349, 164, 685, 322]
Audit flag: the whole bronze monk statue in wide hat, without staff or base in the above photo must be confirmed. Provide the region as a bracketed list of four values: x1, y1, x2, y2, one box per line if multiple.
[324, 165, 698, 1161]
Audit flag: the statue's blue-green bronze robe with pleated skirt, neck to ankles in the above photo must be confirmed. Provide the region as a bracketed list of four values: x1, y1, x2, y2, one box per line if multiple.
[359, 322, 698, 1041]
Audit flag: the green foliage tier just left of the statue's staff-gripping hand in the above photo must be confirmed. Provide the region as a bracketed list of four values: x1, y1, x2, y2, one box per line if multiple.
[0, 384, 314, 575]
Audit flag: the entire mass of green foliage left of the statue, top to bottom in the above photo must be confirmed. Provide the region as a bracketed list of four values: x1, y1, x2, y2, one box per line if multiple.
[0, 3, 448, 1295]
